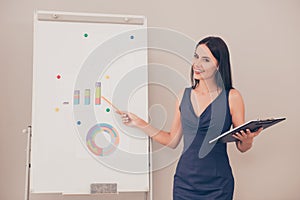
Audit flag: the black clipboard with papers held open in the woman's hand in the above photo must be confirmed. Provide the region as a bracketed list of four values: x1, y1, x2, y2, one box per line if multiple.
[209, 118, 286, 144]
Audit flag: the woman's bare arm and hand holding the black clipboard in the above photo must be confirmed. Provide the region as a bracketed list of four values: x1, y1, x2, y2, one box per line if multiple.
[229, 89, 262, 152]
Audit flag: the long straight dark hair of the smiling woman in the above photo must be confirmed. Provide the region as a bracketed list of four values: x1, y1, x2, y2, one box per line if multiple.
[191, 36, 233, 90]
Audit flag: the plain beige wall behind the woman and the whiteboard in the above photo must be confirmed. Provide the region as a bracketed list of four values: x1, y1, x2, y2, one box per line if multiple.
[0, 0, 300, 200]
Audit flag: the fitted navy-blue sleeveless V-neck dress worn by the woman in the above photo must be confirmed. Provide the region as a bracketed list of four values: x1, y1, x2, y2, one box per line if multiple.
[173, 88, 234, 200]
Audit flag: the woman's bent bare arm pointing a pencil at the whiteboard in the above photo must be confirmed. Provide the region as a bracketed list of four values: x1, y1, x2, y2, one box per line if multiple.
[119, 90, 182, 149]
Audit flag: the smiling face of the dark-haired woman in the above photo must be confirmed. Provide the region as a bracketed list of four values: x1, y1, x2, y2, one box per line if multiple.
[193, 44, 218, 80]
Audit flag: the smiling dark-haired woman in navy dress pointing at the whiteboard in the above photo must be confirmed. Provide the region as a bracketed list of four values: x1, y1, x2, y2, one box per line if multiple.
[119, 37, 262, 200]
